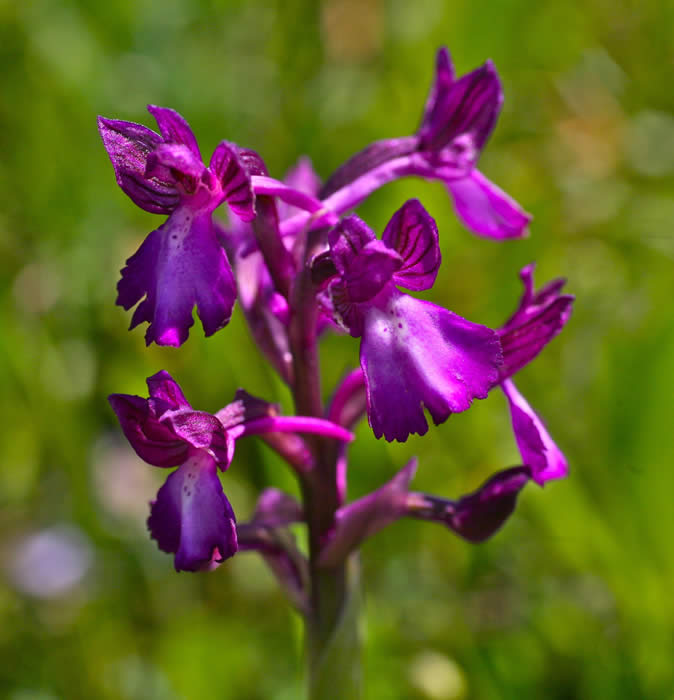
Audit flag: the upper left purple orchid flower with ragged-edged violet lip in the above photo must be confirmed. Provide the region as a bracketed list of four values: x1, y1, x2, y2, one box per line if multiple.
[98, 105, 255, 346]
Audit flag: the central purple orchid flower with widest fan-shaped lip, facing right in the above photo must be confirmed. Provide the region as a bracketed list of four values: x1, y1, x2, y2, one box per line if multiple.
[315, 200, 502, 441]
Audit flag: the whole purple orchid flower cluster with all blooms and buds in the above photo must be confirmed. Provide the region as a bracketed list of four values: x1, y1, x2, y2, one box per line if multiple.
[99, 48, 573, 580]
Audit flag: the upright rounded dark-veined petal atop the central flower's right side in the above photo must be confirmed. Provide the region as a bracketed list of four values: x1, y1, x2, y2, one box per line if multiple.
[382, 199, 441, 291]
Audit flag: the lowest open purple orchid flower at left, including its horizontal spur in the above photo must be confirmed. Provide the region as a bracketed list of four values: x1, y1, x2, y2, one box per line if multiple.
[108, 371, 353, 571]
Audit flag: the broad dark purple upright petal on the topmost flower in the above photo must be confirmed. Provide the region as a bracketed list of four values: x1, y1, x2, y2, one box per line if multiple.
[419, 61, 503, 160]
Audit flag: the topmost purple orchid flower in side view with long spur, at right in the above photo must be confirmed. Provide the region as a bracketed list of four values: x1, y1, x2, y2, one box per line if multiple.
[310, 47, 531, 240]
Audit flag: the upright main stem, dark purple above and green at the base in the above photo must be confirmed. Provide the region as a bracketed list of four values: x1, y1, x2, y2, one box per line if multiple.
[289, 231, 361, 700]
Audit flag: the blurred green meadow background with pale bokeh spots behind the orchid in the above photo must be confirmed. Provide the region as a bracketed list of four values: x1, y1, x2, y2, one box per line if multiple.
[0, 0, 674, 700]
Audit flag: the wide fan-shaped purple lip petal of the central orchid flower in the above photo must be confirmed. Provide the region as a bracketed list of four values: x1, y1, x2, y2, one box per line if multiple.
[360, 289, 502, 441]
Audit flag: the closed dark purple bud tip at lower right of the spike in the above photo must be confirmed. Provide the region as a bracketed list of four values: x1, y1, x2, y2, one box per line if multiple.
[444, 467, 530, 542]
